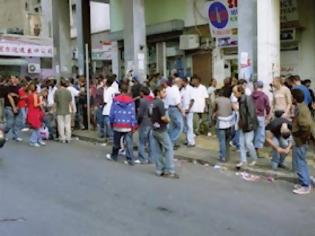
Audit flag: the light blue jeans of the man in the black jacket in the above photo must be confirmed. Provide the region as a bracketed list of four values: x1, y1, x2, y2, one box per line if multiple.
[239, 130, 257, 162]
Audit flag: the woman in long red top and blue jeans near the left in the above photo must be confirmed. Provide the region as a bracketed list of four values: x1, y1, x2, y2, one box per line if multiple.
[27, 83, 46, 147]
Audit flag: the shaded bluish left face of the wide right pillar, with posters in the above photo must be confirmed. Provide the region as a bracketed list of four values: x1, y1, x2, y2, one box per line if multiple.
[238, 0, 258, 81]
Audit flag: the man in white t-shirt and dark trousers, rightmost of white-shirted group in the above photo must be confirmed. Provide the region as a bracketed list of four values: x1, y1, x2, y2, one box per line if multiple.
[192, 76, 209, 133]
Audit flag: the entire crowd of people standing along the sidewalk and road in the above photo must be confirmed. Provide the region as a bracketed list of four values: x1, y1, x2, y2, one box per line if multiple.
[0, 73, 315, 194]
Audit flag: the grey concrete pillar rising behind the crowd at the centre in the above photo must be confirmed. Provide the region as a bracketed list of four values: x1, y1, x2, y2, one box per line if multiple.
[123, 0, 147, 82]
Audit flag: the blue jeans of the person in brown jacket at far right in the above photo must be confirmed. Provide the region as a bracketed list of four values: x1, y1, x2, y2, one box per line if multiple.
[292, 145, 311, 187]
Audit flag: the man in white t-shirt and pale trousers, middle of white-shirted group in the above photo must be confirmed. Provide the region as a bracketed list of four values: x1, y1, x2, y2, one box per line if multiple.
[181, 78, 196, 147]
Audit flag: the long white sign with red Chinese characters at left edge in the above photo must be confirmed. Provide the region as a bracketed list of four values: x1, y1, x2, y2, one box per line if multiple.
[0, 35, 54, 57]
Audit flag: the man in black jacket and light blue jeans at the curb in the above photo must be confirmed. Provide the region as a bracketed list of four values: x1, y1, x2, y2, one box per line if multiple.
[233, 85, 258, 168]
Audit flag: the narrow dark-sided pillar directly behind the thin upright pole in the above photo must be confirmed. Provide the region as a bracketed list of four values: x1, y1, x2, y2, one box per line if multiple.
[75, 0, 91, 75]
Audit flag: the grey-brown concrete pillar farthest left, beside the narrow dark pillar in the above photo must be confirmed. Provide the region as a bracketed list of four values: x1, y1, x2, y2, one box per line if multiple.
[52, 0, 72, 76]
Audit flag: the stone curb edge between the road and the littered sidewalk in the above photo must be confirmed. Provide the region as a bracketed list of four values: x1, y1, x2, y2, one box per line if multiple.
[73, 134, 296, 183]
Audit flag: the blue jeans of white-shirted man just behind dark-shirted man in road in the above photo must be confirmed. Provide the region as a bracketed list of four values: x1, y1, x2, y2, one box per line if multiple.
[168, 107, 184, 145]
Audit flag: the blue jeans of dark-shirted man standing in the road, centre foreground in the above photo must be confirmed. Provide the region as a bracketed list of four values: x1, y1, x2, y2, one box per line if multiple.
[150, 130, 175, 174]
